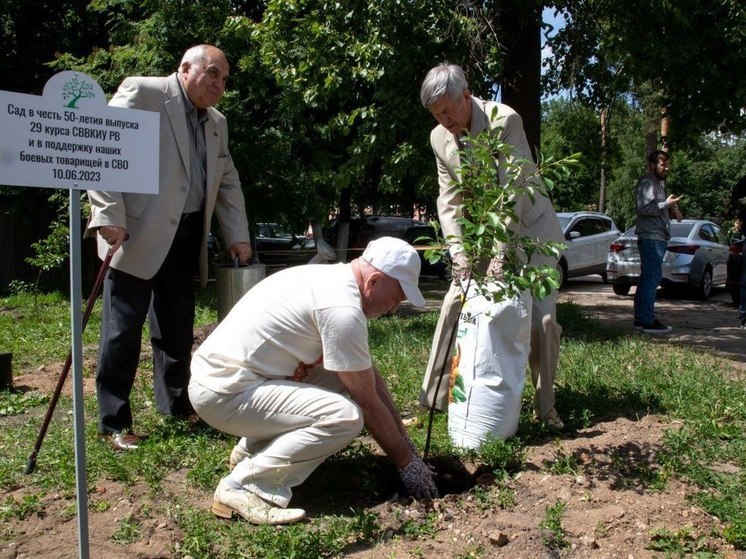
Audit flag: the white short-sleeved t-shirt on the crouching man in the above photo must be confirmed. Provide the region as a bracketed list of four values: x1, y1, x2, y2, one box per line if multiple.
[192, 264, 372, 394]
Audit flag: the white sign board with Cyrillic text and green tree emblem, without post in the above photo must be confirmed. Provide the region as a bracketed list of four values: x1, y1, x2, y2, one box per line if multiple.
[0, 71, 160, 194]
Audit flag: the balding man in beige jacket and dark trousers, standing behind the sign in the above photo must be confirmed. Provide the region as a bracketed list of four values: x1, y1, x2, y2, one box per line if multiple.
[87, 45, 251, 450]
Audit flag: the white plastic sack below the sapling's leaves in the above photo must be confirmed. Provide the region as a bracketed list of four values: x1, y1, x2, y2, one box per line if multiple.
[448, 287, 531, 449]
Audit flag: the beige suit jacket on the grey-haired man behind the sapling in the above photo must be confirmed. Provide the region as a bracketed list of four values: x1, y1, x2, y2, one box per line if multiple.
[430, 97, 564, 258]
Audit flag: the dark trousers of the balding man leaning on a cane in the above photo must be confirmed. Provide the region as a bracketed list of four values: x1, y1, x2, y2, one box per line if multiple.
[96, 212, 202, 433]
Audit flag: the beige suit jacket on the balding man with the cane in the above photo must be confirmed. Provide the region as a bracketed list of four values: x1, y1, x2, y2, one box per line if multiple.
[86, 74, 250, 285]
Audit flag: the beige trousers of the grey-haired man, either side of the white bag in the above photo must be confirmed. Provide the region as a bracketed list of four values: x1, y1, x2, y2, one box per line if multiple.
[420, 282, 562, 419]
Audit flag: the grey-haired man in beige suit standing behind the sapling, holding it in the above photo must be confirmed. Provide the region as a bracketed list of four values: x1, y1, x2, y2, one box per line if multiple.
[420, 64, 564, 429]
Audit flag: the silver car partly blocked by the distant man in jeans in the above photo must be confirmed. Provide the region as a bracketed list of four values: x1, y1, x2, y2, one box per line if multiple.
[606, 219, 729, 301]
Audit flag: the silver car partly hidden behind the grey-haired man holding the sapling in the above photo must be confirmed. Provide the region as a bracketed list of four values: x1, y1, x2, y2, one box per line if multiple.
[557, 212, 621, 285]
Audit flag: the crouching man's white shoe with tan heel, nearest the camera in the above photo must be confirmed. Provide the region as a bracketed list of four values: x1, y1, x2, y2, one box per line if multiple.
[212, 480, 306, 524]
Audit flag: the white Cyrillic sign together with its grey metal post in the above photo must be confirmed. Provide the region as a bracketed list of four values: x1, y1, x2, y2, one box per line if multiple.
[0, 71, 160, 559]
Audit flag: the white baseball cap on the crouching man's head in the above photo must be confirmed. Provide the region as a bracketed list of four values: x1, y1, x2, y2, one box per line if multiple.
[362, 237, 425, 307]
